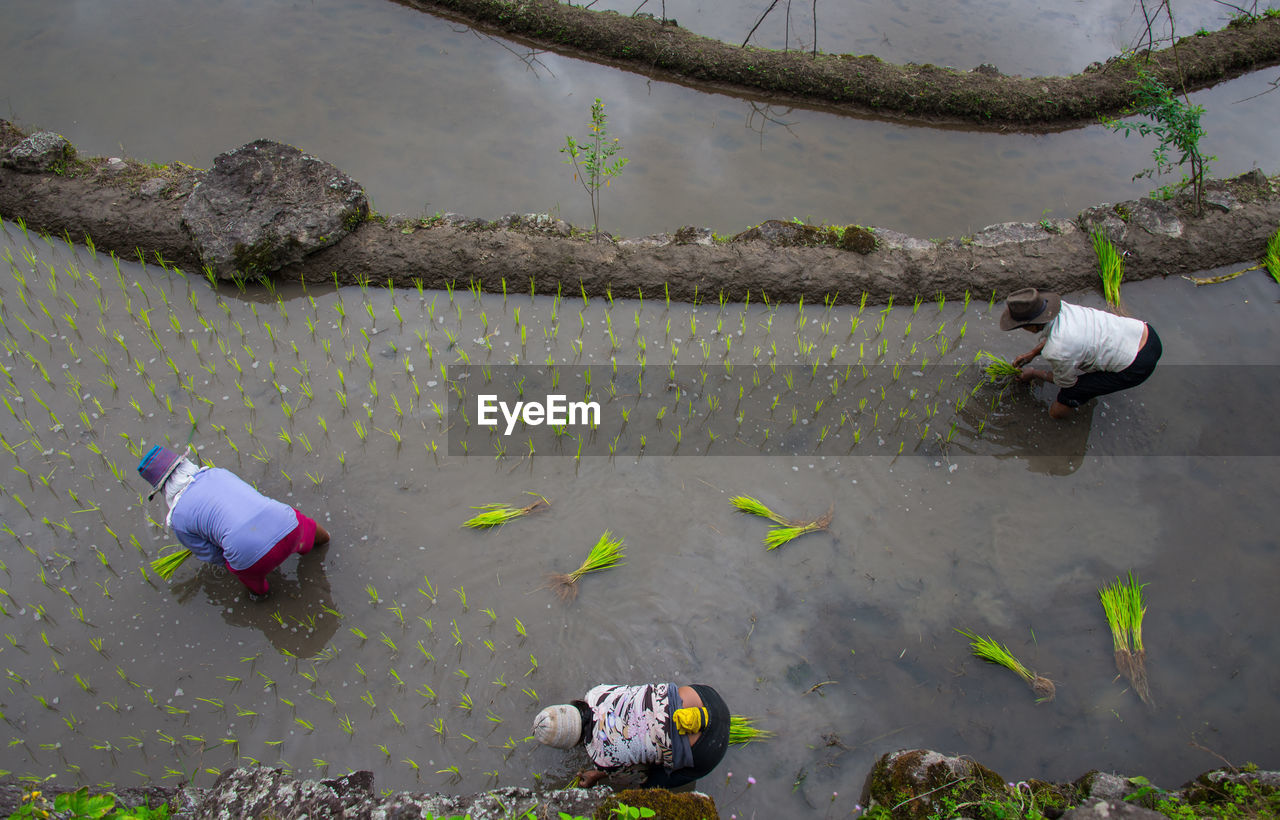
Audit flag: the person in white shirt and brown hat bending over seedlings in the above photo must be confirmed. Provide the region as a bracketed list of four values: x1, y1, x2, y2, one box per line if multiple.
[1000, 288, 1162, 418]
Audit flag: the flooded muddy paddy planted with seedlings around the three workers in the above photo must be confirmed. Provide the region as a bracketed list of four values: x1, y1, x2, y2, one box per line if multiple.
[0, 224, 1280, 816]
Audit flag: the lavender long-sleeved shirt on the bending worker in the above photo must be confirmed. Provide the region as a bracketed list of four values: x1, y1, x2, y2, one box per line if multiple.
[169, 467, 298, 569]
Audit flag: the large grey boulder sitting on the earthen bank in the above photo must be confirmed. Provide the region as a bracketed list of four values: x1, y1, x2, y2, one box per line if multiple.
[182, 139, 369, 279]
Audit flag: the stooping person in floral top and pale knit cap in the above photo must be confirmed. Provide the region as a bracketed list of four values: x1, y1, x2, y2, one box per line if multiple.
[534, 683, 730, 788]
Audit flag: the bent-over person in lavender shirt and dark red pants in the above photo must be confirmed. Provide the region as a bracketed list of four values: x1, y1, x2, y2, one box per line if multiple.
[138, 445, 329, 600]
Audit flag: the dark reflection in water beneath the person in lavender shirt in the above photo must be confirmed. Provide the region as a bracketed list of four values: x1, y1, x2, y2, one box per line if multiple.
[169, 545, 342, 658]
